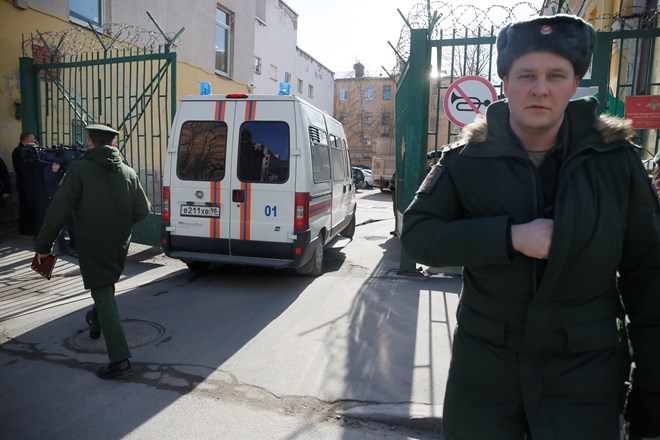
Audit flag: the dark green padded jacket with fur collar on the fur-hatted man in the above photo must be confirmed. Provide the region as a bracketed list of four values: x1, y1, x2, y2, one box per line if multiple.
[401, 99, 660, 438]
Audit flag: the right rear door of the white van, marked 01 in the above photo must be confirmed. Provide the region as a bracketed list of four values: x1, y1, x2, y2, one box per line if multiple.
[229, 98, 297, 259]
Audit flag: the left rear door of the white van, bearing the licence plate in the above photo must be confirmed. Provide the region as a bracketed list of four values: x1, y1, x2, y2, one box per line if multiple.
[168, 99, 236, 254]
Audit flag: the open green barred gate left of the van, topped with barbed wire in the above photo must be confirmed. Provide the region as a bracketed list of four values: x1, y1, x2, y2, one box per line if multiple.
[20, 13, 183, 246]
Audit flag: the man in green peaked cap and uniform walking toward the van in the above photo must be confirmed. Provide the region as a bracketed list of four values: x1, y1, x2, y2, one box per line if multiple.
[34, 125, 151, 379]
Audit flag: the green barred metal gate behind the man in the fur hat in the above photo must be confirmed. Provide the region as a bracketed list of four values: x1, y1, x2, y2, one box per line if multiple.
[396, 3, 660, 271]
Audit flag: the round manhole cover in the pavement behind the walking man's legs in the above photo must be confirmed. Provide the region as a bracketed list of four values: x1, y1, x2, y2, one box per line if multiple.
[65, 319, 165, 353]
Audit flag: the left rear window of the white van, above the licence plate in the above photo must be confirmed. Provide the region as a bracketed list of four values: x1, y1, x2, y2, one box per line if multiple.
[176, 121, 227, 182]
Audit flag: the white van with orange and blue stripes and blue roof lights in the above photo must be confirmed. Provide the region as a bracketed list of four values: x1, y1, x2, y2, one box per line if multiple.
[161, 94, 356, 276]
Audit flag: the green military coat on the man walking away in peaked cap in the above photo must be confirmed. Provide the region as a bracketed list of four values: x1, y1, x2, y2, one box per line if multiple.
[34, 145, 151, 289]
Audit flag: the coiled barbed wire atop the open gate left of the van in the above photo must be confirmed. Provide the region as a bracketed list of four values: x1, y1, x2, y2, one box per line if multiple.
[22, 23, 179, 60]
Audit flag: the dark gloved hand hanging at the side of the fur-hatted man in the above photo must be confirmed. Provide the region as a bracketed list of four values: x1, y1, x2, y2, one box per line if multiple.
[623, 385, 660, 438]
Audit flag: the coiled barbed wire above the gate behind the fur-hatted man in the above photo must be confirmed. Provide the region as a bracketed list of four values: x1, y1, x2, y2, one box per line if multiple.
[392, 0, 660, 74]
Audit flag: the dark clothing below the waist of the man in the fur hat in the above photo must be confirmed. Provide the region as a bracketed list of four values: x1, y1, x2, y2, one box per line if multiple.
[443, 326, 619, 440]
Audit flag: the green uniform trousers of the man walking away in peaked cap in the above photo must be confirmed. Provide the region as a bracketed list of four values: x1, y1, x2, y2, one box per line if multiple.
[90, 284, 131, 362]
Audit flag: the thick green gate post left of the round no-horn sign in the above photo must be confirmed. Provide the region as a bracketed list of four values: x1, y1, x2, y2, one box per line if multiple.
[396, 29, 431, 272]
